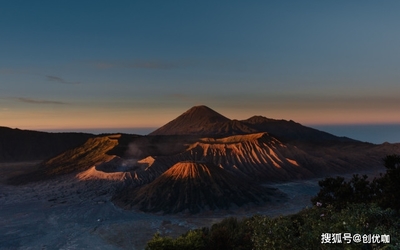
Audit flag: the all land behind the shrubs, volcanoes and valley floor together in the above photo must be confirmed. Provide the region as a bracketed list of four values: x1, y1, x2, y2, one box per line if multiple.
[0, 106, 400, 249]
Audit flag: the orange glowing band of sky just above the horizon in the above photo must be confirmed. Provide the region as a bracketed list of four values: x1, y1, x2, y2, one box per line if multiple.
[0, 105, 400, 131]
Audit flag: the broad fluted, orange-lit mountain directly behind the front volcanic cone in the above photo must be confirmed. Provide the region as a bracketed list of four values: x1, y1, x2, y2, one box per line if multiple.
[134, 133, 378, 182]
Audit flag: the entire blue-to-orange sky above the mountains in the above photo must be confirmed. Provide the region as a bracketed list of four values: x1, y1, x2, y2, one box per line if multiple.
[0, 0, 400, 134]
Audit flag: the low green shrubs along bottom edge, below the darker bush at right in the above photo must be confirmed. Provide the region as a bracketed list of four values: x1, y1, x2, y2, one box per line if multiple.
[146, 203, 400, 250]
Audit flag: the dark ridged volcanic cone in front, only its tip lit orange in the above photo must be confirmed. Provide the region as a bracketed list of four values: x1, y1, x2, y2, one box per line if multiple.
[114, 161, 283, 213]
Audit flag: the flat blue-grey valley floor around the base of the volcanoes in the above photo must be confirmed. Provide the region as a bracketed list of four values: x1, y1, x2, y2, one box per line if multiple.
[0, 162, 383, 249]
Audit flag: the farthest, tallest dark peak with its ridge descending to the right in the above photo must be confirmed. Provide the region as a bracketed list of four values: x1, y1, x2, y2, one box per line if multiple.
[149, 105, 356, 143]
